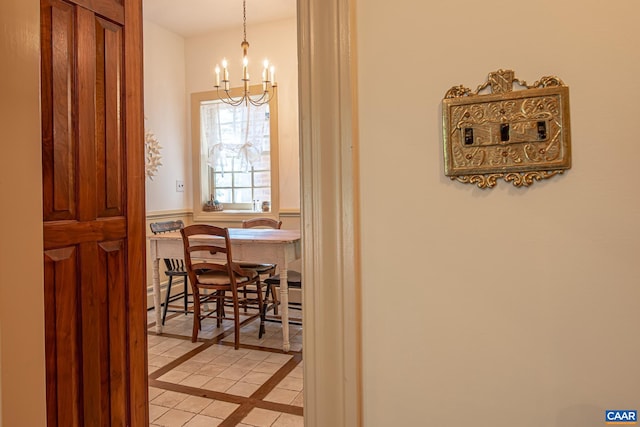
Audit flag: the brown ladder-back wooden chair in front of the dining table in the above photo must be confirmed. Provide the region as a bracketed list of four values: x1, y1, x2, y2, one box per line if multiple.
[180, 224, 263, 350]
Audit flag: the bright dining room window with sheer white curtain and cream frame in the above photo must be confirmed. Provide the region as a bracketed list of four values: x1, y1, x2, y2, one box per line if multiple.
[191, 86, 278, 219]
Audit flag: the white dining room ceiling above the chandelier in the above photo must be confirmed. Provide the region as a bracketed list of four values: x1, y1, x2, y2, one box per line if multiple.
[143, 0, 296, 38]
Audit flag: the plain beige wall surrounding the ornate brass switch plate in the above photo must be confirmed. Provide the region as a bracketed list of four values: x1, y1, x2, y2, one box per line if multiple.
[356, 0, 640, 427]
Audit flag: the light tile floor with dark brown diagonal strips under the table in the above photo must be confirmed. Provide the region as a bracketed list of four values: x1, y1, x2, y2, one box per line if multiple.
[147, 310, 304, 427]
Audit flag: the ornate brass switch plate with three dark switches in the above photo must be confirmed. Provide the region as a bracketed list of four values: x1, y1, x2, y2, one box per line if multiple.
[442, 70, 571, 188]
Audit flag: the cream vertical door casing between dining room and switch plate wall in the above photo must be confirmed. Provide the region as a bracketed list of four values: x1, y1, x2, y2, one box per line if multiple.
[298, 0, 362, 427]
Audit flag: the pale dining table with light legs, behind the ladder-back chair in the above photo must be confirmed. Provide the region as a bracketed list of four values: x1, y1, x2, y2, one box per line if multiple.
[147, 228, 301, 352]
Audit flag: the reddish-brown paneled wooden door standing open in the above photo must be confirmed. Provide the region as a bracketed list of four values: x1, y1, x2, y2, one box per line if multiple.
[40, 0, 148, 427]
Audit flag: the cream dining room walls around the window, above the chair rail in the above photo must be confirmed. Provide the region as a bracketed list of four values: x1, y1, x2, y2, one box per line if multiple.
[144, 18, 300, 214]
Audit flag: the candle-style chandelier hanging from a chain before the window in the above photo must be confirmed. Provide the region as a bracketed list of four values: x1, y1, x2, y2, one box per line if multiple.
[214, 0, 278, 107]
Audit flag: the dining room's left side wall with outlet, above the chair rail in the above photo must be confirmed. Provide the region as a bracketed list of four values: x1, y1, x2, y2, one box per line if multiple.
[143, 21, 192, 212]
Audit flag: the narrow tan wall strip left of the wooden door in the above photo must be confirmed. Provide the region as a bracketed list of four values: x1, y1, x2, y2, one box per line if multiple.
[0, 0, 46, 427]
